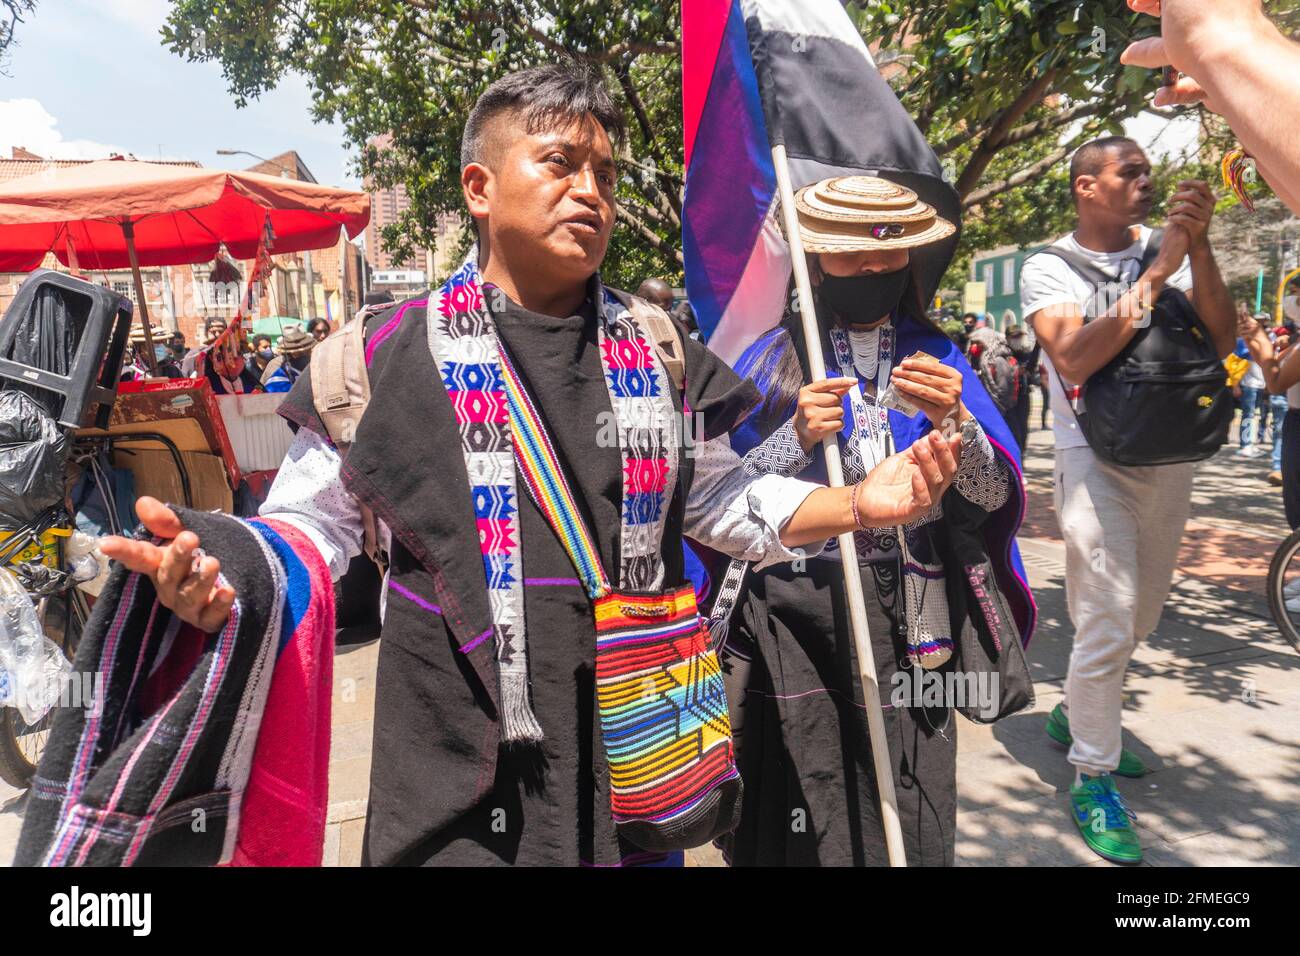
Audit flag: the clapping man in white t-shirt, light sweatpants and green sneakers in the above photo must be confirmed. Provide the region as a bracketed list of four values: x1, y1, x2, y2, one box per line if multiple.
[1021, 137, 1236, 862]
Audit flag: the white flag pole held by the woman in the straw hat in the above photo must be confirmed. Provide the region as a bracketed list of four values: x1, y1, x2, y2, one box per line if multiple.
[772, 146, 907, 866]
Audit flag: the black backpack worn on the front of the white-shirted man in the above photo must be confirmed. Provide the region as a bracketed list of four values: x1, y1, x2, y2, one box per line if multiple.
[1043, 229, 1234, 466]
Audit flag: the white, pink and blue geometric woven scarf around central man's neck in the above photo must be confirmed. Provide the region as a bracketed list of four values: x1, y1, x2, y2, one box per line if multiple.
[429, 254, 677, 741]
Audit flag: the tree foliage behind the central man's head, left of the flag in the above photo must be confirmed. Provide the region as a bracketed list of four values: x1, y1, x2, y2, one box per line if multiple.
[164, 0, 684, 286]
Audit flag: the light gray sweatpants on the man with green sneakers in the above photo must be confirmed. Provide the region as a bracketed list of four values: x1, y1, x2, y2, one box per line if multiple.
[1056, 446, 1196, 774]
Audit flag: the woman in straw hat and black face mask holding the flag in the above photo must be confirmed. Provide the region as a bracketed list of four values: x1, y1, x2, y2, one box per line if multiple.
[714, 176, 1032, 865]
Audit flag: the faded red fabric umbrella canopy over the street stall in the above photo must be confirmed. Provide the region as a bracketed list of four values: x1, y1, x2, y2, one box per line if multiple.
[0, 160, 371, 272]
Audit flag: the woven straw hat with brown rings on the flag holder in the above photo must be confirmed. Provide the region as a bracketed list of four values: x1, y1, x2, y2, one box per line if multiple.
[794, 176, 957, 252]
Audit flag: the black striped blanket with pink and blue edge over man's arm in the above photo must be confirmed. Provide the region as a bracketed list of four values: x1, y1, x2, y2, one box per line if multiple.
[14, 509, 334, 866]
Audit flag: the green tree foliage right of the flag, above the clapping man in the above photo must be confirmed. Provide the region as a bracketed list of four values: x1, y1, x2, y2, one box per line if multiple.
[849, 0, 1300, 287]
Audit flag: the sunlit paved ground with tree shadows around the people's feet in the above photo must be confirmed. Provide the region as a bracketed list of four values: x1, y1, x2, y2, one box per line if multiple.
[0, 403, 1300, 866]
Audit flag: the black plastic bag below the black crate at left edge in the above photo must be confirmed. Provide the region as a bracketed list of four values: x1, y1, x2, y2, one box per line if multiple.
[0, 389, 68, 529]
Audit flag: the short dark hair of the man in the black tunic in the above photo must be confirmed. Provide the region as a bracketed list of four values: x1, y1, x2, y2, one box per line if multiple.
[460, 62, 627, 169]
